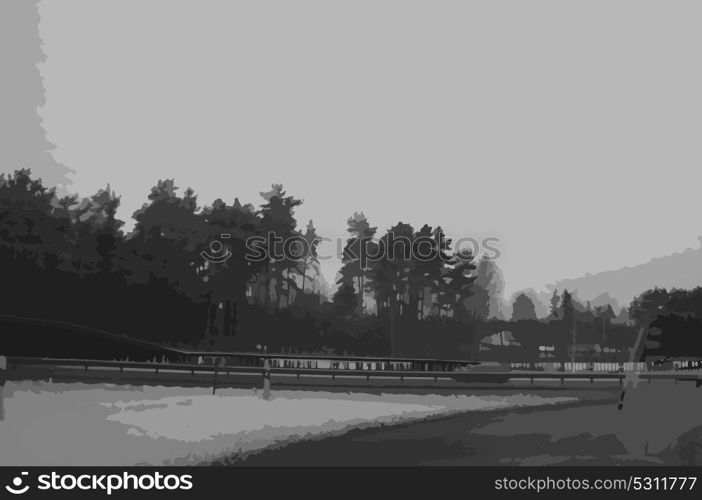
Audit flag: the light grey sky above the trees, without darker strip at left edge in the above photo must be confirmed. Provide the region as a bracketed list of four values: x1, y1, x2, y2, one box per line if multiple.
[30, 0, 702, 294]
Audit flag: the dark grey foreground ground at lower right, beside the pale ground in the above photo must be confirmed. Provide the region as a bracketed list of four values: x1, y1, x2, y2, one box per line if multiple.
[217, 384, 702, 466]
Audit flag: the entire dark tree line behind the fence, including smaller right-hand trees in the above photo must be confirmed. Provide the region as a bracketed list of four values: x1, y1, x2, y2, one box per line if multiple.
[5, 169, 702, 358]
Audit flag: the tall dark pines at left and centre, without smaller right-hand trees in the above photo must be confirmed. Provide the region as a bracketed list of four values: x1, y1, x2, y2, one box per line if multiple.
[0, 169, 492, 354]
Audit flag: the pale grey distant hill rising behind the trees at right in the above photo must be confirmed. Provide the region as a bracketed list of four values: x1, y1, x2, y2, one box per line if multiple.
[548, 238, 702, 307]
